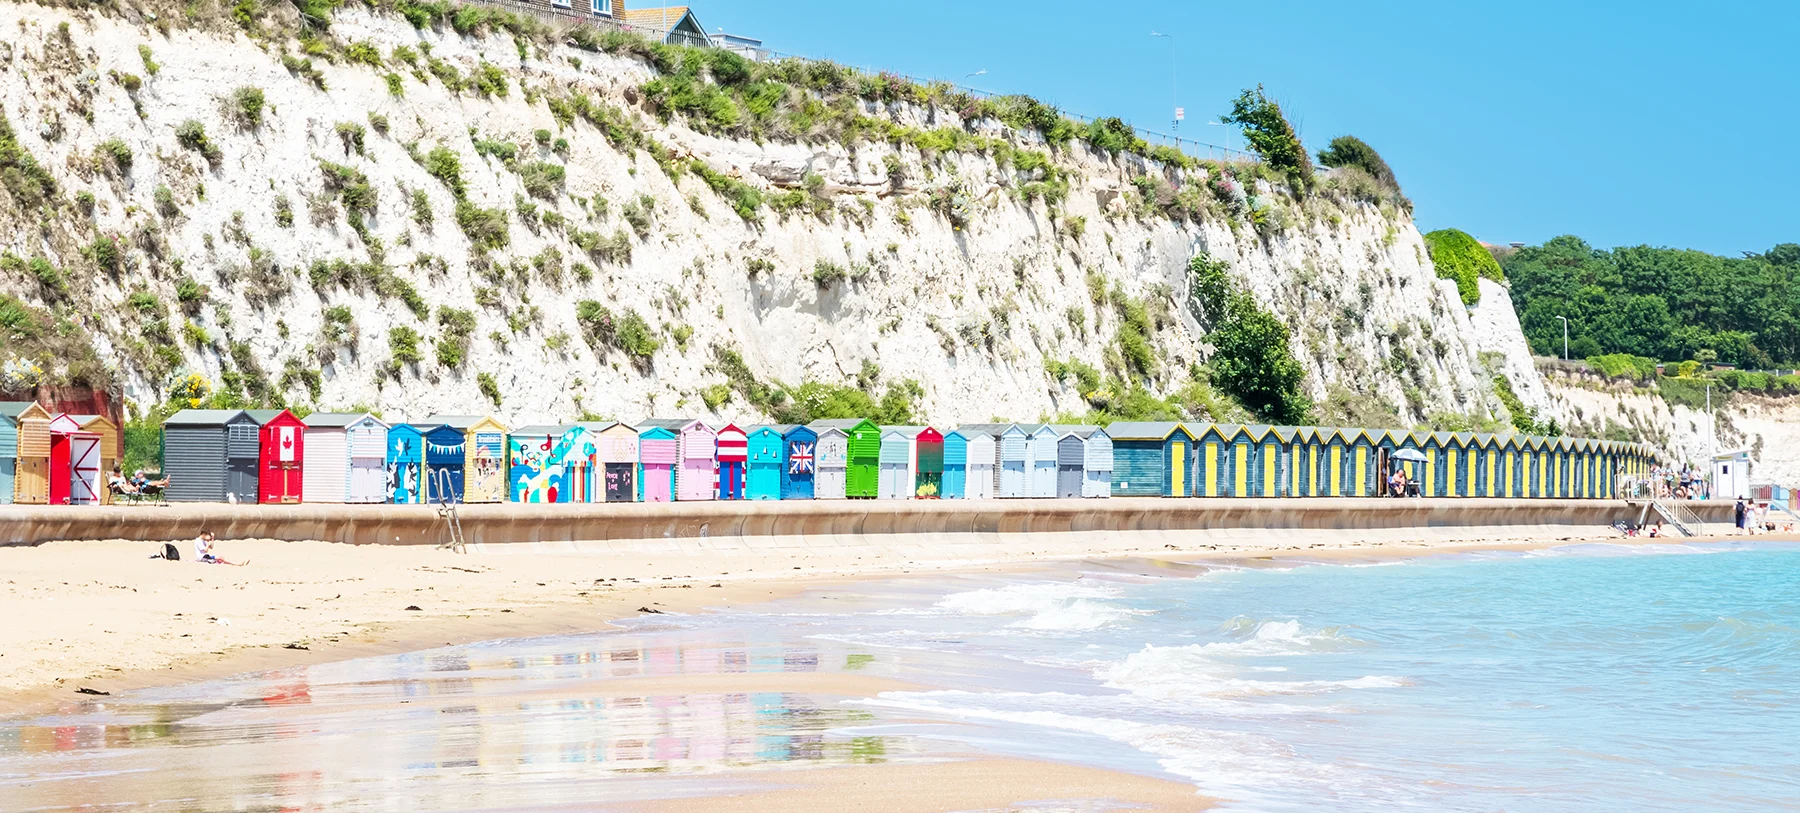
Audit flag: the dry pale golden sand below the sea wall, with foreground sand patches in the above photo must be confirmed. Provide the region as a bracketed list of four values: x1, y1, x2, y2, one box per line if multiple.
[0, 529, 1785, 811]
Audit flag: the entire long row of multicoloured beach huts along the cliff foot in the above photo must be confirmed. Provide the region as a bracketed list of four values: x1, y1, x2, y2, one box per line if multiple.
[0, 403, 1654, 504]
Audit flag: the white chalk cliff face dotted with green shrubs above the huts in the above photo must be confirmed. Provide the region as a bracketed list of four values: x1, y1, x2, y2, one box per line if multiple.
[0, 4, 1605, 431]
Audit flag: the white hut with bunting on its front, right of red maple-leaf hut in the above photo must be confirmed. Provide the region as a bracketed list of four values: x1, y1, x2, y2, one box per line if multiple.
[301, 412, 387, 504]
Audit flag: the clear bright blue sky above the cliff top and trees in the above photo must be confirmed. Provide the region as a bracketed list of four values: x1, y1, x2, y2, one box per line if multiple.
[680, 0, 1800, 255]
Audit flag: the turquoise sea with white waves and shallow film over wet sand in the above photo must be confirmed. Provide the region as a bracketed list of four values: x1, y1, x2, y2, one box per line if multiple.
[0, 541, 1800, 813]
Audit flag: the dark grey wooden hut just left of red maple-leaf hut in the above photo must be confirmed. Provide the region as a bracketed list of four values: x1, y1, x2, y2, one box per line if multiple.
[162, 410, 261, 504]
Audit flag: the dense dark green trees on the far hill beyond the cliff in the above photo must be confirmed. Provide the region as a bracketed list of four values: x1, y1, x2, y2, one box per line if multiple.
[1501, 236, 1800, 369]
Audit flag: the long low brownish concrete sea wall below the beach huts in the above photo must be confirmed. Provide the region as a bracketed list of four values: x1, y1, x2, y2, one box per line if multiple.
[0, 498, 1732, 550]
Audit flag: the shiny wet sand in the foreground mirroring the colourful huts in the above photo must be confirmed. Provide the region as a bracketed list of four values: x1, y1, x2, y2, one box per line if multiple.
[0, 630, 911, 811]
